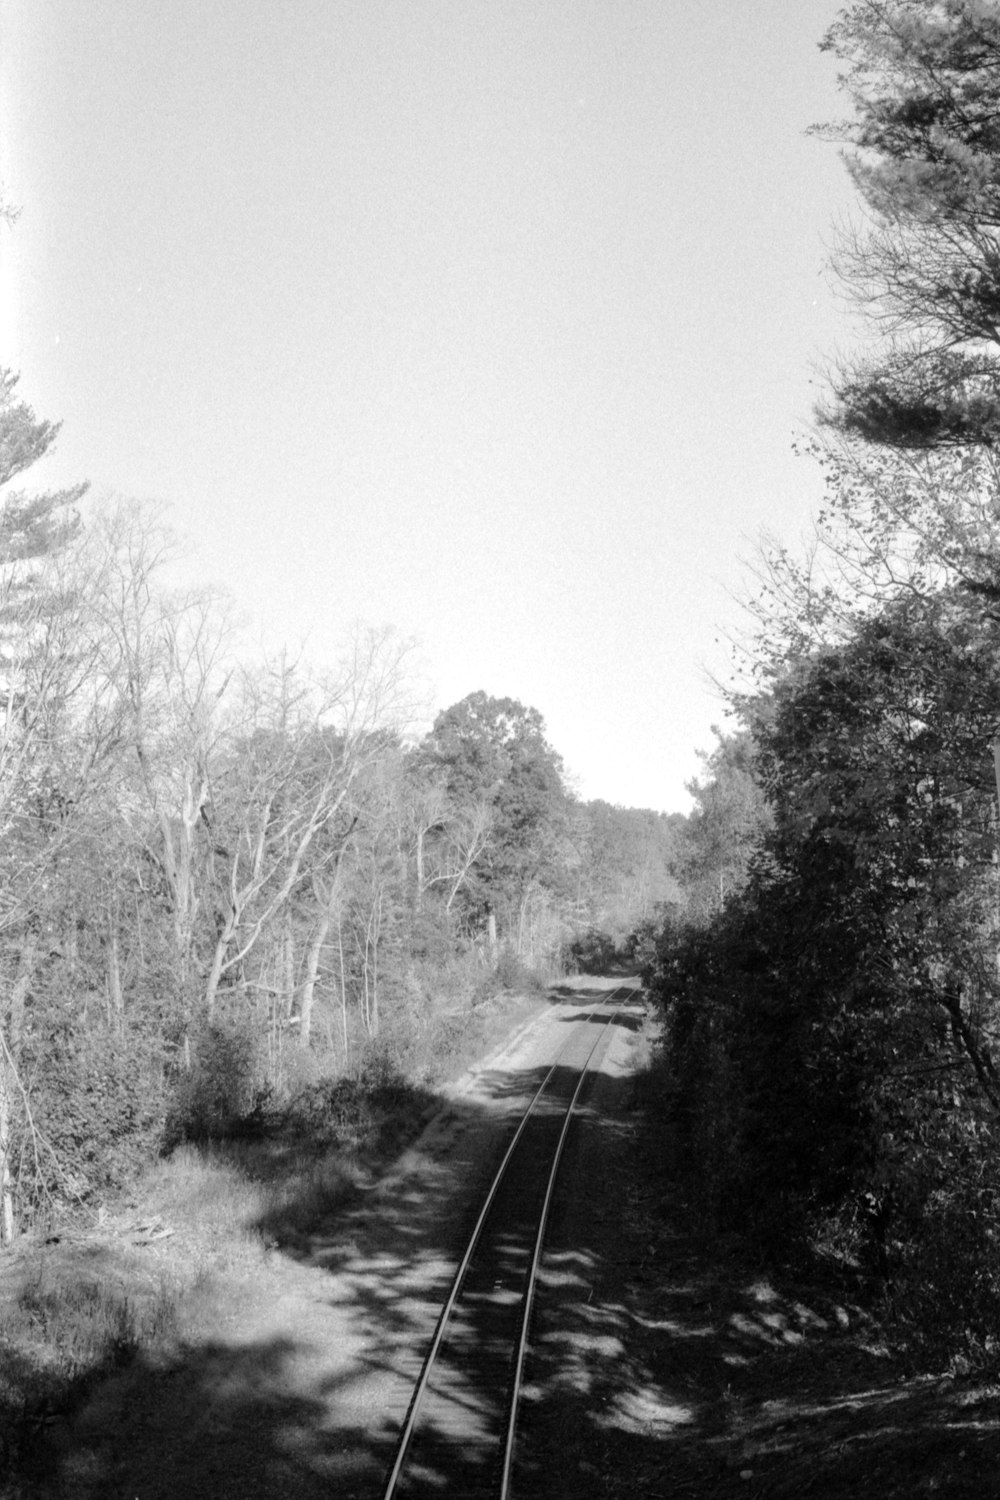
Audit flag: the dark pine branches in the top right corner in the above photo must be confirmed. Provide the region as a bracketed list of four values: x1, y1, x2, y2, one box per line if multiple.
[817, 0, 1000, 449]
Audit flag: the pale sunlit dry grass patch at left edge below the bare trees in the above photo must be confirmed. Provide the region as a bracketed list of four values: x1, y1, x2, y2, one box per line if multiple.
[0, 1143, 357, 1467]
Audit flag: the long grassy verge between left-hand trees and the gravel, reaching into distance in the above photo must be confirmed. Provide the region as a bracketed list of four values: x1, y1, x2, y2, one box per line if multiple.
[0, 993, 543, 1482]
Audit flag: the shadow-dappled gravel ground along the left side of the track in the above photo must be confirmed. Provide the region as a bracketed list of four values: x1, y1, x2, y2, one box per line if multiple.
[21, 995, 632, 1500]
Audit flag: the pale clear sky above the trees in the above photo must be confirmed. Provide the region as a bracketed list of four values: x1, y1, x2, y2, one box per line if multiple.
[0, 0, 850, 810]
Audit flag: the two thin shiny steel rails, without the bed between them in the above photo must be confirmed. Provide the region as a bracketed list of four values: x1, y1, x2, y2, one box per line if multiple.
[382, 986, 636, 1500]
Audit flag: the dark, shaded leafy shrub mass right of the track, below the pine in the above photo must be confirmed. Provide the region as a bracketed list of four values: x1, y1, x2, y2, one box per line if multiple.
[649, 599, 1000, 1358]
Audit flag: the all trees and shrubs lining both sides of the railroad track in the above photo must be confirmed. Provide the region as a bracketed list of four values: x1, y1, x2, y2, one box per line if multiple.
[9, 0, 1000, 1380]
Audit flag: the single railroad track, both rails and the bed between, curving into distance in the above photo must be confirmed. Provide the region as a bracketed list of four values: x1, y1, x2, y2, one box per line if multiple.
[382, 986, 639, 1500]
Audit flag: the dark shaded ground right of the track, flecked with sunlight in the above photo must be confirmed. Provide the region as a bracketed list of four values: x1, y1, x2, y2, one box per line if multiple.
[516, 1056, 1000, 1500]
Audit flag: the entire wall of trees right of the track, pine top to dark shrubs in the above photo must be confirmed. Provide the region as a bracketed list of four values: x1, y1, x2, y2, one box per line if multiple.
[651, 0, 1000, 1361]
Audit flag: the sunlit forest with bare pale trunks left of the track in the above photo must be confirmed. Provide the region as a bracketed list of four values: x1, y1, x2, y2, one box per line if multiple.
[0, 387, 682, 1244]
